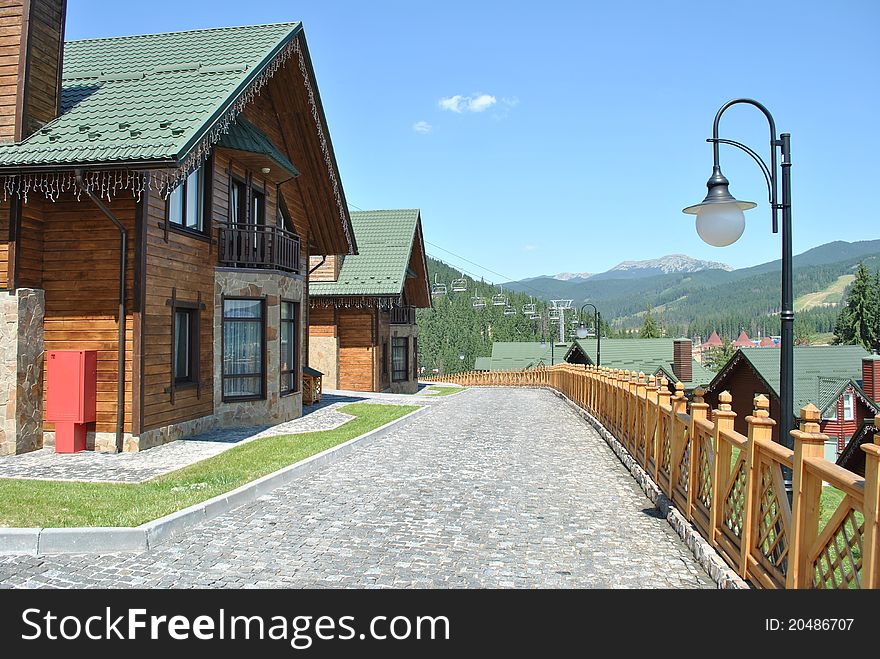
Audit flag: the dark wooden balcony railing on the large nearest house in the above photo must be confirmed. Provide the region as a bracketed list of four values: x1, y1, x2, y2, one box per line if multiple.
[218, 224, 300, 272]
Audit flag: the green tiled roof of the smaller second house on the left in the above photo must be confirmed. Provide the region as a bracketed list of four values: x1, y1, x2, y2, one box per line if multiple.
[309, 208, 419, 297]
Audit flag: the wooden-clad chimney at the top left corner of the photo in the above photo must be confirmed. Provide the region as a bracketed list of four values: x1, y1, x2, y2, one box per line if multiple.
[0, 0, 67, 143]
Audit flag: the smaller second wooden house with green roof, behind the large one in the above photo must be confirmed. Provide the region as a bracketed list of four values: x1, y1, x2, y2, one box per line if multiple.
[309, 210, 431, 393]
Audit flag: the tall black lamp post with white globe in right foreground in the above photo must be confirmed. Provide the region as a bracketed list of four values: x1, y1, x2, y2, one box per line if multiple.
[683, 98, 794, 466]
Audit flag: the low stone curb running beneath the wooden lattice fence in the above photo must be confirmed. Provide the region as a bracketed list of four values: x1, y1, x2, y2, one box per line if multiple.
[550, 389, 750, 590]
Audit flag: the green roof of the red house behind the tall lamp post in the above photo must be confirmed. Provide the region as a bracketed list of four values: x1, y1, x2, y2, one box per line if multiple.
[719, 346, 868, 416]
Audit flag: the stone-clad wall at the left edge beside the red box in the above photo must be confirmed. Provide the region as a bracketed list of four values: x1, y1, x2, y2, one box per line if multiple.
[0, 288, 46, 455]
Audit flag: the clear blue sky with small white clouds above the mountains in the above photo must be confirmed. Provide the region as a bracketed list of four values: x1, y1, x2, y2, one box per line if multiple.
[67, 0, 880, 280]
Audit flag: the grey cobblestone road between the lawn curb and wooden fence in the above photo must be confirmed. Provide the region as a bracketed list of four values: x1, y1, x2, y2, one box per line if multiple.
[0, 389, 713, 588]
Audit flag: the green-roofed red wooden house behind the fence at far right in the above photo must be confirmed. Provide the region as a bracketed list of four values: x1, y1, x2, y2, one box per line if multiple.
[706, 346, 880, 461]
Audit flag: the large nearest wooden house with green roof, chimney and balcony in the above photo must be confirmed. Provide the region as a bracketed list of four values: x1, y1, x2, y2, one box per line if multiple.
[0, 10, 356, 453]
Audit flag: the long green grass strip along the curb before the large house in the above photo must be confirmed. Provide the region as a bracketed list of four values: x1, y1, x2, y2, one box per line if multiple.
[0, 403, 418, 527]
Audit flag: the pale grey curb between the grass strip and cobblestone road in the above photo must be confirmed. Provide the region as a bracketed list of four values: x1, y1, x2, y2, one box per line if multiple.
[0, 407, 431, 556]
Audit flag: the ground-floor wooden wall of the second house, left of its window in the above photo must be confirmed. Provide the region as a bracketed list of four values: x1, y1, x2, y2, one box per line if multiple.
[338, 309, 377, 391]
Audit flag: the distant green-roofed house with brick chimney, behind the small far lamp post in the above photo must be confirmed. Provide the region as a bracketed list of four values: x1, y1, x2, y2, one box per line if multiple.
[565, 338, 714, 391]
